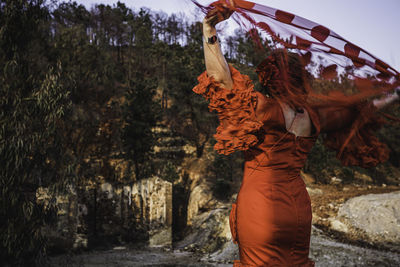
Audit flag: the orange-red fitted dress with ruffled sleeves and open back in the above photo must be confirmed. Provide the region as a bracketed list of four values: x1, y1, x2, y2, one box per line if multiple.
[193, 66, 387, 266]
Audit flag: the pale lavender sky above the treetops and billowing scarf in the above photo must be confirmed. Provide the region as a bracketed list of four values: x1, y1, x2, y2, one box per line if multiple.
[75, 0, 400, 71]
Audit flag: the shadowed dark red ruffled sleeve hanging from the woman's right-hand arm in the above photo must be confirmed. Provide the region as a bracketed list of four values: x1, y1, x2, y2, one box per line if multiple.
[325, 102, 389, 168]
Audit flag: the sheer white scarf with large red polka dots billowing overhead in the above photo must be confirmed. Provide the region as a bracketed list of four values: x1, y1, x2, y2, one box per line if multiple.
[193, 0, 400, 83]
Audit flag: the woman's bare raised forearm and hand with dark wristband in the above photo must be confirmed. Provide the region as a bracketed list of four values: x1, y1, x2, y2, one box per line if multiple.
[203, 3, 233, 89]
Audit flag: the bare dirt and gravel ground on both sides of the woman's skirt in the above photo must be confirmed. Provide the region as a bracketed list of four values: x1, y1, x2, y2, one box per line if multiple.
[49, 184, 400, 267]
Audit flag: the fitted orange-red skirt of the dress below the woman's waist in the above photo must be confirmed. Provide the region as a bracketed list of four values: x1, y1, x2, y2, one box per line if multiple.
[229, 173, 314, 267]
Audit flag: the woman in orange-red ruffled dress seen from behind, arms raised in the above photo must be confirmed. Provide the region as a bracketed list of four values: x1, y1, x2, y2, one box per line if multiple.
[193, 2, 399, 266]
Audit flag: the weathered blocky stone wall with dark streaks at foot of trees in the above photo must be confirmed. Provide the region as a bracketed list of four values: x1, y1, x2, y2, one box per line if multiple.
[37, 177, 172, 250]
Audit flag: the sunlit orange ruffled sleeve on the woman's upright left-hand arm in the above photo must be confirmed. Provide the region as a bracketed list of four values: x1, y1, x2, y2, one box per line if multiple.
[193, 66, 263, 155]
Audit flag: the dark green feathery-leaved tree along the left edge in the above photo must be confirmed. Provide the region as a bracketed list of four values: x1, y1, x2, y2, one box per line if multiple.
[0, 0, 73, 266]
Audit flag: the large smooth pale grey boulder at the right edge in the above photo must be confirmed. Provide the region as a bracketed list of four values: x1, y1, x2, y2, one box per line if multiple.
[337, 191, 400, 244]
